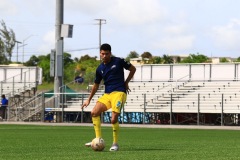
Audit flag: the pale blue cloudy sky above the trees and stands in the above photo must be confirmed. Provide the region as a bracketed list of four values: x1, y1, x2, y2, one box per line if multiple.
[0, 0, 240, 61]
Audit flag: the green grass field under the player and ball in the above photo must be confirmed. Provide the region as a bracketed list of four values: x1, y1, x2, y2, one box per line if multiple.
[0, 124, 240, 160]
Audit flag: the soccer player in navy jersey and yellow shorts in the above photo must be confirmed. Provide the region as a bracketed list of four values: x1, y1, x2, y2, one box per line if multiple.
[82, 44, 136, 151]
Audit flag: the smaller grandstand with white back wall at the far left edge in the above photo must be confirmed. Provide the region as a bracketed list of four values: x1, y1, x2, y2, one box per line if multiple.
[0, 65, 42, 120]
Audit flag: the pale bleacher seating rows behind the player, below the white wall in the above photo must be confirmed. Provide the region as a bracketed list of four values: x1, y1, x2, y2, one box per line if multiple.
[61, 81, 240, 123]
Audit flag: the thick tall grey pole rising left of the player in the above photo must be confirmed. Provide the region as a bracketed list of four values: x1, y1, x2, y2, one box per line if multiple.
[54, 0, 64, 122]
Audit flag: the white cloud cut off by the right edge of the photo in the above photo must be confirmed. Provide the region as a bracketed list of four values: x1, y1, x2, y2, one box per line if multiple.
[211, 19, 240, 50]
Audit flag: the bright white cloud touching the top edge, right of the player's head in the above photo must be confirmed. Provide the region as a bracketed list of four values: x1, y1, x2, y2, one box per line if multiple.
[108, 0, 166, 26]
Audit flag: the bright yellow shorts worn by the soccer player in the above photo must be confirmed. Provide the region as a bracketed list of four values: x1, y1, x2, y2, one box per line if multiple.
[98, 92, 127, 113]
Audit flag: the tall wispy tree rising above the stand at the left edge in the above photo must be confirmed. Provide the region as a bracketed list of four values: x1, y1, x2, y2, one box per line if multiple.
[0, 20, 16, 62]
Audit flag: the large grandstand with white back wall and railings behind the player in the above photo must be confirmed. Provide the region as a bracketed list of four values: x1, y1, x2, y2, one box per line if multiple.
[4, 63, 240, 125]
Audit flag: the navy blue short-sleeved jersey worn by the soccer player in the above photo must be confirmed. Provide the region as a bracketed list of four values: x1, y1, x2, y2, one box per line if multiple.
[94, 57, 131, 93]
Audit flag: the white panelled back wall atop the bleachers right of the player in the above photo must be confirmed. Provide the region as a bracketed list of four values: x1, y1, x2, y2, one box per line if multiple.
[125, 63, 240, 81]
